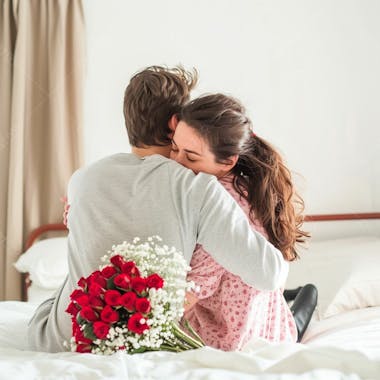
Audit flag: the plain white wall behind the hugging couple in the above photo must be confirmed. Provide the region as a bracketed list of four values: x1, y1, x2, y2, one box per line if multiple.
[84, 0, 380, 213]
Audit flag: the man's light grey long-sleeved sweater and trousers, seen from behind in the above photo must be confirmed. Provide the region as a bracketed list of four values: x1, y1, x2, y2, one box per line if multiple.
[28, 154, 287, 352]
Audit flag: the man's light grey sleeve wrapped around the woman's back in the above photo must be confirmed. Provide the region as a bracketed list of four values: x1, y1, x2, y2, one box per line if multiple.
[197, 178, 289, 290]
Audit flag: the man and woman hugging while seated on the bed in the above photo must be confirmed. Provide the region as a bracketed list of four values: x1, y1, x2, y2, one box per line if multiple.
[28, 66, 314, 352]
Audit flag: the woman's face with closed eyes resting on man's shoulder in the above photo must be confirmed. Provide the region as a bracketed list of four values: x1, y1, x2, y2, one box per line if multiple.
[170, 121, 234, 178]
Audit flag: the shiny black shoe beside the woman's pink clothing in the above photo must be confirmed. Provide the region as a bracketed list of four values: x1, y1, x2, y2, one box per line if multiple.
[290, 284, 318, 342]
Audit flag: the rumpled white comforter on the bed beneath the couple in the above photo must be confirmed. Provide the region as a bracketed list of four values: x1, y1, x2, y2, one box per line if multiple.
[0, 302, 380, 380]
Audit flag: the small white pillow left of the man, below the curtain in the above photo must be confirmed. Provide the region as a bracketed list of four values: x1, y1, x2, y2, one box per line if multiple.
[14, 237, 68, 289]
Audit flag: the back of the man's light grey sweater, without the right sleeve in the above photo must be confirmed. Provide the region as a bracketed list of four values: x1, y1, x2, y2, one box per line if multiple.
[68, 154, 206, 278]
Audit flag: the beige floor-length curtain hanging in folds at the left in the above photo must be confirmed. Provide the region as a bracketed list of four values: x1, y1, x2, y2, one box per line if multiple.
[0, 0, 85, 300]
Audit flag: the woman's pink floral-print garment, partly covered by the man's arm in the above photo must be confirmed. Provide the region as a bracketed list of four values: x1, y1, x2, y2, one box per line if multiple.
[184, 176, 297, 351]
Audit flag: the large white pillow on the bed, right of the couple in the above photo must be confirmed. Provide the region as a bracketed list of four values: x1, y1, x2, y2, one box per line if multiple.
[286, 236, 380, 319]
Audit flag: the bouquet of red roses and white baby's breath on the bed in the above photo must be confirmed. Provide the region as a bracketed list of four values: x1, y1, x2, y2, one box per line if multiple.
[66, 236, 204, 354]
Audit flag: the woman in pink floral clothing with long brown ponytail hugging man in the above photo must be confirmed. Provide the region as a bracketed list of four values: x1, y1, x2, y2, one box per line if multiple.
[171, 94, 308, 351]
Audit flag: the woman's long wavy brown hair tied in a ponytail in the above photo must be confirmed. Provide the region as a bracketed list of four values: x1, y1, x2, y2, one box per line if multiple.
[180, 94, 309, 261]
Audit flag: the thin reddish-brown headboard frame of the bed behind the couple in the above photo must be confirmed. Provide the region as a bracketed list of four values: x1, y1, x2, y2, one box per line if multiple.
[22, 212, 380, 301]
